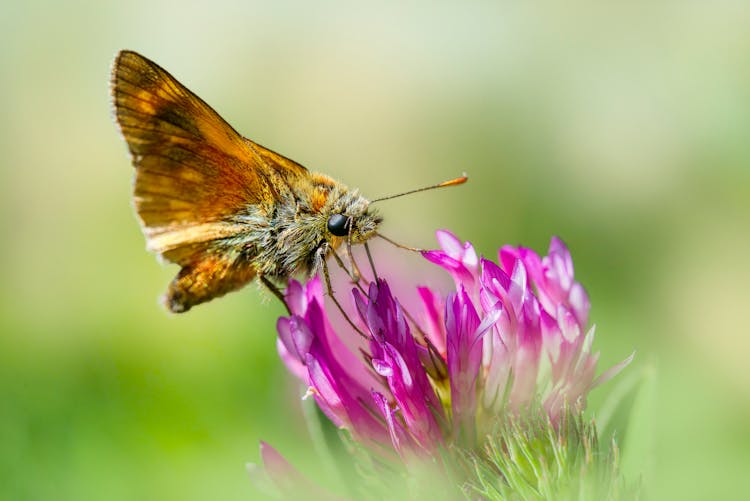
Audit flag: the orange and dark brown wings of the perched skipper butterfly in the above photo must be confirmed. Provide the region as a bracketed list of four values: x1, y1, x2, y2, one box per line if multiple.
[112, 51, 307, 312]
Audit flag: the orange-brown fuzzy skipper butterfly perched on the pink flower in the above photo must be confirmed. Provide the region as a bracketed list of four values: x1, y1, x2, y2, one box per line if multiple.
[111, 50, 466, 313]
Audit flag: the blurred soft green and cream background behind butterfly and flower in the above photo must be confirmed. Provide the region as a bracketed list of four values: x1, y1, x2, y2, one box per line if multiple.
[0, 0, 750, 500]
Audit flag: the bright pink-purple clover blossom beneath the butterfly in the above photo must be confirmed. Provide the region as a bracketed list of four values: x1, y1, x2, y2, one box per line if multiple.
[258, 231, 632, 498]
